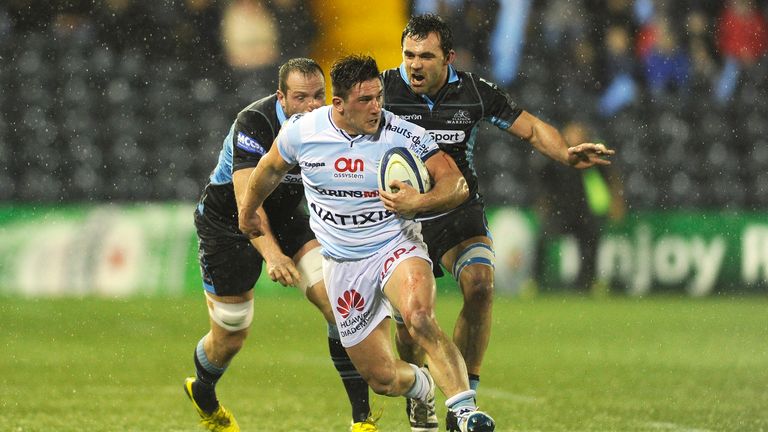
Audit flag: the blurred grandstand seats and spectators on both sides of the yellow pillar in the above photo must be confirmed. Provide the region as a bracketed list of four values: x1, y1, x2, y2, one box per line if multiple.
[0, 0, 768, 209]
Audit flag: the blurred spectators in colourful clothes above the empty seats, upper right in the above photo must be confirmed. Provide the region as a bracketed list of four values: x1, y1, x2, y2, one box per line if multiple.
[440, 0, 768, 118]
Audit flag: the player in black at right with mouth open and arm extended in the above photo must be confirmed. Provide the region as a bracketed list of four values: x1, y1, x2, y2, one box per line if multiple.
[382, 14, 613, 432]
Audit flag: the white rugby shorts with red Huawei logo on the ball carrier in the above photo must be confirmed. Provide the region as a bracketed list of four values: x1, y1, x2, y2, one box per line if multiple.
[323, 234, 432, 347]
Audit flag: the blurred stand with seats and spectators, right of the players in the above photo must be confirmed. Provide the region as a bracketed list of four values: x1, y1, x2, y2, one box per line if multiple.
[444, 0, 768, 209]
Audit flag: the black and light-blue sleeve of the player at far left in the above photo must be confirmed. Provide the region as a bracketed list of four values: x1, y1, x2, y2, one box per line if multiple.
[232, 111, 277, 172]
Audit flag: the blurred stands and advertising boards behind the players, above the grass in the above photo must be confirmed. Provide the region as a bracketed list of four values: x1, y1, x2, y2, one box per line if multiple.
[0, 0, 768, 295]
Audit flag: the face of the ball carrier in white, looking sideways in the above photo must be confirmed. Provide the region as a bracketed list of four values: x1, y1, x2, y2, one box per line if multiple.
[341, 78, 384, 135]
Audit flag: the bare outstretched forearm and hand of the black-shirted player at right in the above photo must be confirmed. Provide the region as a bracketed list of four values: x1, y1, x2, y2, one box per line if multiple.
[507, 111, 615, 169]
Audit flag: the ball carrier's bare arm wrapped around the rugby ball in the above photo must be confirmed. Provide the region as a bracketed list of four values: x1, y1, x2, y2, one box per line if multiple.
[379, 150, 469, 215]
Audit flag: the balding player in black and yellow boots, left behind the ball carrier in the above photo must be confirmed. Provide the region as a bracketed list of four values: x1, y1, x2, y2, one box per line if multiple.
[184, 58, 378, 432]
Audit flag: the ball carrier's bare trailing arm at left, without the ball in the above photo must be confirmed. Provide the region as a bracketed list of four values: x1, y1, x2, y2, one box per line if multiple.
[238, 145, 291, 238]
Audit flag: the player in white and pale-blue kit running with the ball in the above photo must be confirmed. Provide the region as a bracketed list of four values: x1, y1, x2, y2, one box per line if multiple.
[239, 56, 495, 432]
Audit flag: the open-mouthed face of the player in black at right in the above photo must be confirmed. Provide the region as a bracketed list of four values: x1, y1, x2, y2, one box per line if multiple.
[403, 32, 453, 96]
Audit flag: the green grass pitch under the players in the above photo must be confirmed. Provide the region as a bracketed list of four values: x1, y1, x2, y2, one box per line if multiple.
[0, 295, 768, 432]
